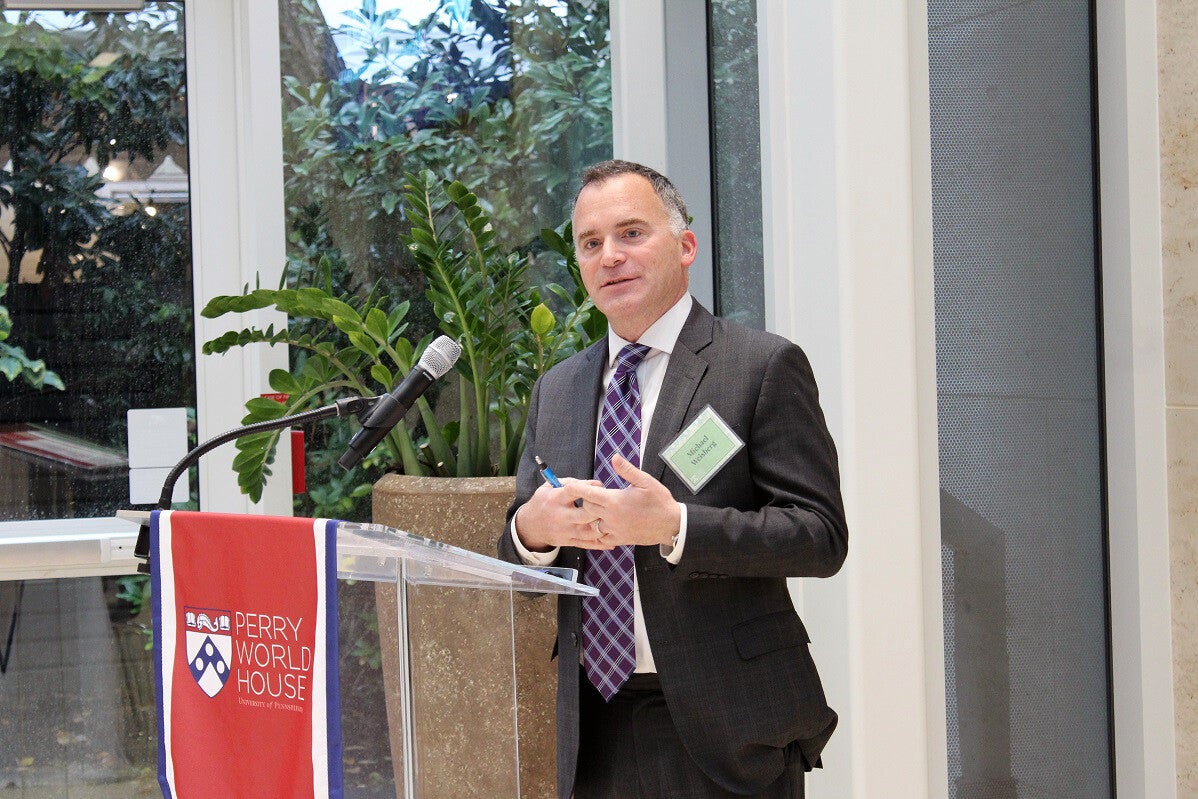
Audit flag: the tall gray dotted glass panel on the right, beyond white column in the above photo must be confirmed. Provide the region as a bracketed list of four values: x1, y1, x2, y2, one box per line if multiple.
[928, 0, 1112, 799]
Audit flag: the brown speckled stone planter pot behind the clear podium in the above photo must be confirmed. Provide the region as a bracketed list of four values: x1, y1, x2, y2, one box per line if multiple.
[374, 474, 557, 799]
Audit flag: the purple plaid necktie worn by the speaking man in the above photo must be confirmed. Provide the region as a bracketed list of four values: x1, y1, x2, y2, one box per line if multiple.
[582, 344, 649, 701]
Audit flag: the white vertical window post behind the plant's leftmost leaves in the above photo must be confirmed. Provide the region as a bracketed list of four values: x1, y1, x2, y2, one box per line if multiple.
[194, 0, 291, 515]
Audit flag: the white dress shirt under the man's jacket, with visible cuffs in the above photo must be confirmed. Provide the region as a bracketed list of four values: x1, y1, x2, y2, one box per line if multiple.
[510, 293, 692, 672]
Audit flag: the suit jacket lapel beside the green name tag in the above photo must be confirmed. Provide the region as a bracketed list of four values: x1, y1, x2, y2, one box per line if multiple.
[641, 302, 715, 480]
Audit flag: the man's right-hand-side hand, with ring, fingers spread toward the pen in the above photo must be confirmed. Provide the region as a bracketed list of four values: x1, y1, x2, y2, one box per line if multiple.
[574, 455, 682, 549]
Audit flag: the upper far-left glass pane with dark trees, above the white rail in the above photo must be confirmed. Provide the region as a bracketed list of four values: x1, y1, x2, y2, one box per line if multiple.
[0, 2, 195, 521]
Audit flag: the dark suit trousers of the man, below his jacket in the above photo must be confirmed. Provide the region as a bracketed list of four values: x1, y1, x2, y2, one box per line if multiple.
[574, 673, 804, 799]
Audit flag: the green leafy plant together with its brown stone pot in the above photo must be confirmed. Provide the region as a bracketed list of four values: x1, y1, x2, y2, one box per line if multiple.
[202, 172, 606, 795]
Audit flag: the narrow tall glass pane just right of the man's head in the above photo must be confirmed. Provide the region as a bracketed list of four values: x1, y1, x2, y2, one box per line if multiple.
[707, 0, 766, 328]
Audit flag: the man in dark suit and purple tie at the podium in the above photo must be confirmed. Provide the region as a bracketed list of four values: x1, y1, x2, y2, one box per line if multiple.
[500, 161, 847, 799]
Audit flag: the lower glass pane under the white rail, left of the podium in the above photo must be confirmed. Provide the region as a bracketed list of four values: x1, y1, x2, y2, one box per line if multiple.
[0, 577, 158, 799]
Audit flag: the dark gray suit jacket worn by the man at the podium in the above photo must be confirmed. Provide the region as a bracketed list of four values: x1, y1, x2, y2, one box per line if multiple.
[500, 302, 848, 799]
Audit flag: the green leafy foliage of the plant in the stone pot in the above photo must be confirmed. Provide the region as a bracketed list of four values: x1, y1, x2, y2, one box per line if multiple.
[202, 172, 605, 500]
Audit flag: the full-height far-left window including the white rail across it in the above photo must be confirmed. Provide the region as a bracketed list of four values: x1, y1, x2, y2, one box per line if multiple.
[0, 2, 195, 795]
